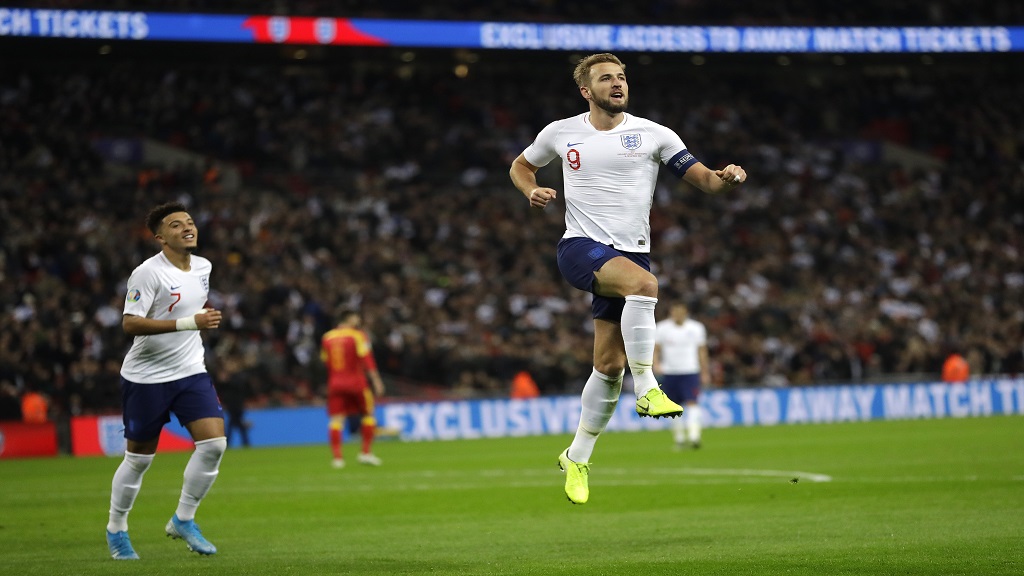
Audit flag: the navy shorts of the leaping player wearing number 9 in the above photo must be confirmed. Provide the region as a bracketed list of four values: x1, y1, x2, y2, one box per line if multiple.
[558, 238, 650, 322]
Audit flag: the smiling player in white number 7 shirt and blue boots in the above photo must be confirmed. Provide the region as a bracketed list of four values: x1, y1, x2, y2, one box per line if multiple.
[106, 202, 227, 560]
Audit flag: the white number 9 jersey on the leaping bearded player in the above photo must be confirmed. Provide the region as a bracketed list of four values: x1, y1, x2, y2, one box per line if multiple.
[523, 112, 695, 253]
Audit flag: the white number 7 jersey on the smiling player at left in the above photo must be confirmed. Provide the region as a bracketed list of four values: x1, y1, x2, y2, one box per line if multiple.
[121, 252, 213, 384]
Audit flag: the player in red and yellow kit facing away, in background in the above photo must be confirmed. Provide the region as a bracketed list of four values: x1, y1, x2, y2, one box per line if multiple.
[321, 310, 384, 468]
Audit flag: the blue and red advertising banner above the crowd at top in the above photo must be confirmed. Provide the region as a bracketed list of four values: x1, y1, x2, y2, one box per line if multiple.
[0, 7, 1024, 53]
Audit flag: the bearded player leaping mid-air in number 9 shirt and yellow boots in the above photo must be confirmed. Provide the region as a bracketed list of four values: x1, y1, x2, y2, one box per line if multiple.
[509, 53, 746, 504]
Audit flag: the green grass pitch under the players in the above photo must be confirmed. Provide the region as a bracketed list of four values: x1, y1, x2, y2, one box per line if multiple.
[0, 416, 1024, 576]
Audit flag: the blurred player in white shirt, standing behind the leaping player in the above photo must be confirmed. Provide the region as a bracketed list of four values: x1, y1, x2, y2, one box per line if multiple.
[654, 302, 711, 448]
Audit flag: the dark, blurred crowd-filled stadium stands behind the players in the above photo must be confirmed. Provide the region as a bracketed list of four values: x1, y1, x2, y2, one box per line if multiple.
[0, 0, 1024, 453]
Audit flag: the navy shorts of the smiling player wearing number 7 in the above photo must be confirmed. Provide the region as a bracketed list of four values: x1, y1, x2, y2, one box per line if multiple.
[121, 372, 224, 442]
